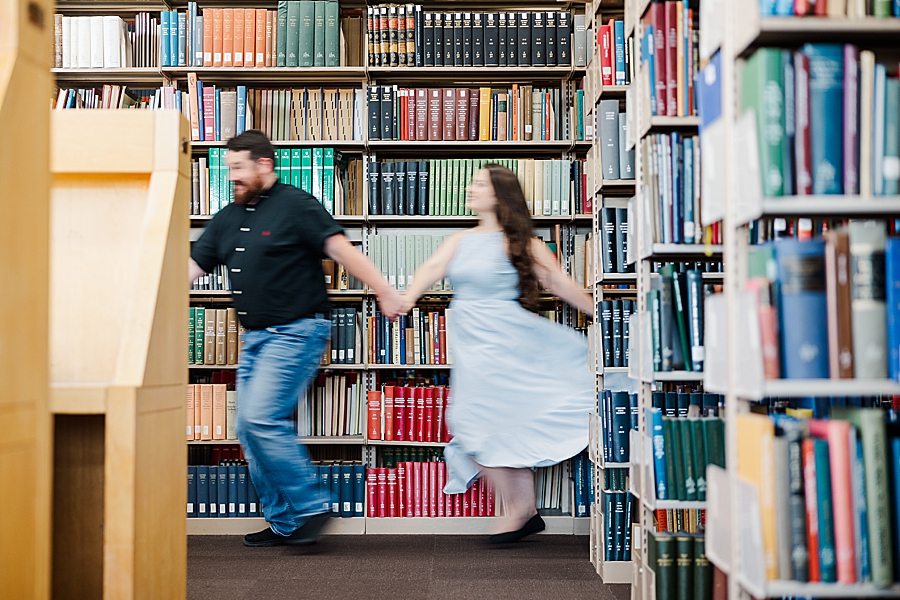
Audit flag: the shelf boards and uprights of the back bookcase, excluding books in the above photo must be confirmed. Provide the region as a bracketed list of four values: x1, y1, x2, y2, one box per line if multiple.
[52, 0, 592, 534]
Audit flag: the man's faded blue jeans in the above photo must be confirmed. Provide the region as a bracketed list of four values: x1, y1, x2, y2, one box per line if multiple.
[235, 319, 331, 535]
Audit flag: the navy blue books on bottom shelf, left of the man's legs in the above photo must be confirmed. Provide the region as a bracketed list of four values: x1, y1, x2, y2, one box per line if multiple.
[187, 464, 262, 519]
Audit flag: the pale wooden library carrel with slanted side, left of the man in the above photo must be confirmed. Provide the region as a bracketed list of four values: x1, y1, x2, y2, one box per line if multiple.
[50, 110, 190, 598]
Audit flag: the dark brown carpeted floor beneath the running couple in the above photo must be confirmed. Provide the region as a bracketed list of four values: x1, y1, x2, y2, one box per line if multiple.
[187, 535, 630, 600]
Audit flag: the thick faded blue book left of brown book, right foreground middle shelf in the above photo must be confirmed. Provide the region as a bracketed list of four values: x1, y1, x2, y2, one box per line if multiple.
[775, 239, 829, 379]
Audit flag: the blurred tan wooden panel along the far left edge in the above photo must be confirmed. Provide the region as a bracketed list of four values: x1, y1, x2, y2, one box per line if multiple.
[0, 0, 53, 599]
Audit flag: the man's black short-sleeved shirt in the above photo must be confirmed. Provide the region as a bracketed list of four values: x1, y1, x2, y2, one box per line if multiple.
[191, 183, 344, 329]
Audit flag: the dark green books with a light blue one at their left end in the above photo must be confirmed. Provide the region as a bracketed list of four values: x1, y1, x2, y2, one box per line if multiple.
[646, 408, 725, 501]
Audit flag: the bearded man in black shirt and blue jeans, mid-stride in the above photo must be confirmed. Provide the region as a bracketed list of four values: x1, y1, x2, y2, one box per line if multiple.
[189, 130, 401, 546]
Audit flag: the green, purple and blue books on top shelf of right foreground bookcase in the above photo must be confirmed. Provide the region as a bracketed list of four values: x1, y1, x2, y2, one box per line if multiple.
[741, 44, 900, 196]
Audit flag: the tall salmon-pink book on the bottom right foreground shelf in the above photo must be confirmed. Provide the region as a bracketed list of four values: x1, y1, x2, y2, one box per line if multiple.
[809, 419, 857, 583]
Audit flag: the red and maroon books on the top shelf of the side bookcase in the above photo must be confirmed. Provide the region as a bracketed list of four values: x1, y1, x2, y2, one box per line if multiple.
[641, 0, 700, 117]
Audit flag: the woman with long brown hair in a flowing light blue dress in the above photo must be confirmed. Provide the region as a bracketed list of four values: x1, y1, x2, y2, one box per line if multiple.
[403, 164, 594, 543]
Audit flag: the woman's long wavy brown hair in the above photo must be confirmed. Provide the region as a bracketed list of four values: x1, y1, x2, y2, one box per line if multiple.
[484, 163, 541, 310]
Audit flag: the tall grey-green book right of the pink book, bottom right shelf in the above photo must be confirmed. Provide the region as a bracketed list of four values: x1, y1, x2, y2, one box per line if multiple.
[831, 408, 894, 587]
